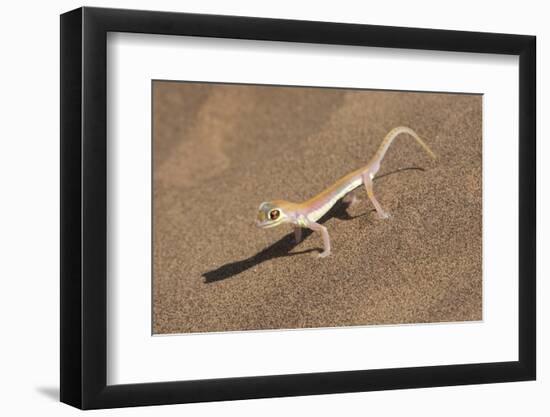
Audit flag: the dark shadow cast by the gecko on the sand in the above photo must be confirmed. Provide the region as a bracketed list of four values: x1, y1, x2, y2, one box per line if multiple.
[202, 167, 424, 284]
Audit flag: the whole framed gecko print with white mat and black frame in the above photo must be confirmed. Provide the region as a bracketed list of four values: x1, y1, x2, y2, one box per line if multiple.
[61, 8, 536, 409]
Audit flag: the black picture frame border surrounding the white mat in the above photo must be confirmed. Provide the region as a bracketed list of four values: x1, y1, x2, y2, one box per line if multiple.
[60, 7, 536, 409]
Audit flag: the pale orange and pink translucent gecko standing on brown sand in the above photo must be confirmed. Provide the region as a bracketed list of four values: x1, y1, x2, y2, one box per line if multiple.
[256, 126, 436, 258]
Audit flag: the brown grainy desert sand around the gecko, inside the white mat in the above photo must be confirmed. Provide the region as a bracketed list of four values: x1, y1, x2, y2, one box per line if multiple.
[153, 81, 482, 334]
